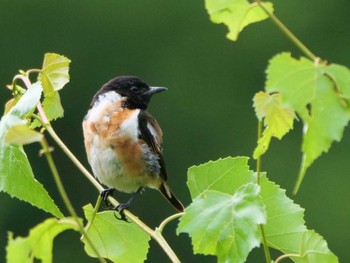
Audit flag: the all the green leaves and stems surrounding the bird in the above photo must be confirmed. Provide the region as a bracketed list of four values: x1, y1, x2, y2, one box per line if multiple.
[0, 0, 350, 263]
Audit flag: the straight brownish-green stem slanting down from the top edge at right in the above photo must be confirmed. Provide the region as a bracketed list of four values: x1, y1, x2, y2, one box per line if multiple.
[256, 0, 317, 61]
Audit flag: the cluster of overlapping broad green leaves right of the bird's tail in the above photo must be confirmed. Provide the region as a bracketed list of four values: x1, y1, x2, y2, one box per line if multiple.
[178, 157, 336, 262]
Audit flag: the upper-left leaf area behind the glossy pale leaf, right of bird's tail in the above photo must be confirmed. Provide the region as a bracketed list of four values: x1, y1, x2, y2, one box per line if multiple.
[187, 157, 253, 199]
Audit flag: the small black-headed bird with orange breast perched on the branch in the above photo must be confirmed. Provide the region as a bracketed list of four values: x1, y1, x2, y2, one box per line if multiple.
[83, 76, 184, 217]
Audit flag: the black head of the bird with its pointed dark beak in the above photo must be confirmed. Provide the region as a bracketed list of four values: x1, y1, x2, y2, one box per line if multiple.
[92, 76, 166, 110]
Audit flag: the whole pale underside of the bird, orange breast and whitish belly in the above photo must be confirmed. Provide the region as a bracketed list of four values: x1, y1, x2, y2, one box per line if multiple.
[83, 97, 162, 193]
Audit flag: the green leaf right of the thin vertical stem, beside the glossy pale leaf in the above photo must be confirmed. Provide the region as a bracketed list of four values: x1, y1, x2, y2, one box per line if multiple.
[260, 174, 306, 254]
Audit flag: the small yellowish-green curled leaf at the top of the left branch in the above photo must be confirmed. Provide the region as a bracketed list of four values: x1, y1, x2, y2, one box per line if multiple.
[39, 53, 71, 94]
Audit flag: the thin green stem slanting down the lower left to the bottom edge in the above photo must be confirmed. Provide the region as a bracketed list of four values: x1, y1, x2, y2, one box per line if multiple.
[40, 137, 107, 263]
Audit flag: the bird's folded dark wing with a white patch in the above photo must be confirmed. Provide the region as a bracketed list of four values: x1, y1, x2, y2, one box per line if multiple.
[139, 110, 168, 181]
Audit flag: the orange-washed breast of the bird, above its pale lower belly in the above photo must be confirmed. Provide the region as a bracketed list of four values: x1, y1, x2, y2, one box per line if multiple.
[83, 101, 147, 182]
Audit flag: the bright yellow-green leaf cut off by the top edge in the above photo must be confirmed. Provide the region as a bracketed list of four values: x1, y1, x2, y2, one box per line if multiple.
[205, 0, 273, 41]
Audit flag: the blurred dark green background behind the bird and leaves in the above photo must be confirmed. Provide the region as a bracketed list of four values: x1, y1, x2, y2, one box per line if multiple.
[0, 0, 350, 262]
